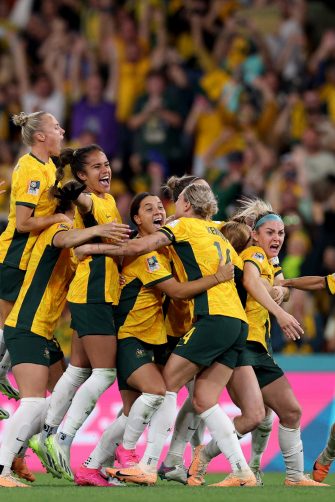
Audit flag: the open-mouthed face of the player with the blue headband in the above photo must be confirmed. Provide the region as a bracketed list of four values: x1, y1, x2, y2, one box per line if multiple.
[253, 220, 285, 258]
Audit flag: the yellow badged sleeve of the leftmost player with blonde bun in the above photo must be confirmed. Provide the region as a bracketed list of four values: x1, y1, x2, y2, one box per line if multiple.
[15, 160, 48, 208]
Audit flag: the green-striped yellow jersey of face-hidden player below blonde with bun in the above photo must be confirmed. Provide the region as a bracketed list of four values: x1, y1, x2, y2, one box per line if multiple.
[5, 223, 74, 340]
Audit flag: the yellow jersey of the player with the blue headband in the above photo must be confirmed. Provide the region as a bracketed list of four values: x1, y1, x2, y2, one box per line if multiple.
[240, 246, 281, 351]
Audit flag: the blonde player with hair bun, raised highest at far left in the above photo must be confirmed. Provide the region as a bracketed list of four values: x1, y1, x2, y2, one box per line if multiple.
[0, 111, 69, 399]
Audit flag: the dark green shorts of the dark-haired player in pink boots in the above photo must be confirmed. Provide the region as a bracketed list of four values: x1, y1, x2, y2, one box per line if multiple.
[117, 337, 170, 390]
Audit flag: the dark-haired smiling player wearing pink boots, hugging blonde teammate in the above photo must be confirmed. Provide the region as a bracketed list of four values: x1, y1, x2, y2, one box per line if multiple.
[75, 192, 233, 486]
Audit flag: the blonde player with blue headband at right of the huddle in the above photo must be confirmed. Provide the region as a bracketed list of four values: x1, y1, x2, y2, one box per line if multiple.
[190, 201, 330, 486]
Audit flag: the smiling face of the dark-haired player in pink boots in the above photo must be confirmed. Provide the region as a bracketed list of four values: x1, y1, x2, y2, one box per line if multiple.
[134, 195, 166, 235]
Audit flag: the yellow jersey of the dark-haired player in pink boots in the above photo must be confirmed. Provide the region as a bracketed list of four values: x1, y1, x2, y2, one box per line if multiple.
[115, 249, 172, 345]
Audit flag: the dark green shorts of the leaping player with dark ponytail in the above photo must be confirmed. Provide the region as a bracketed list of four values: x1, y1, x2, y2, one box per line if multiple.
[69, 302, 116, 338]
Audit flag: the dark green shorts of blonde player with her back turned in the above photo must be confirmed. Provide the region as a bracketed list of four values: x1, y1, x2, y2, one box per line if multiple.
[173, 315, 248, 369]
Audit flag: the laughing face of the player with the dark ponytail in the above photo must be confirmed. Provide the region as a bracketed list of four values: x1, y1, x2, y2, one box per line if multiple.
[78, 150, 112, 195]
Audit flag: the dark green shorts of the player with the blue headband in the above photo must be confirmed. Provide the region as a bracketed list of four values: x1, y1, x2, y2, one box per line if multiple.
[238, 341, 284, 389]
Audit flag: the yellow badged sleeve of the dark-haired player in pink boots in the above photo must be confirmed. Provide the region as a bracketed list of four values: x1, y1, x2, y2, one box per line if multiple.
[138, 251, 172, 288]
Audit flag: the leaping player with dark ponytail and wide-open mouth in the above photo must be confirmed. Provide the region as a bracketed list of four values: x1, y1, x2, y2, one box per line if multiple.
[38, 145, 129, 480]
